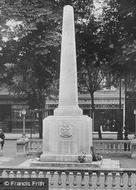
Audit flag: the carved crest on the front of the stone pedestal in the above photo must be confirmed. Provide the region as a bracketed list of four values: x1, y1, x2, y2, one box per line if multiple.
[60, 122, 72, 138]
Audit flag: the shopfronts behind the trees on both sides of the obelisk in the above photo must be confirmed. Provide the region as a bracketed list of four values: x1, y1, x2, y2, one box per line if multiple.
[0, 90, 131, 132]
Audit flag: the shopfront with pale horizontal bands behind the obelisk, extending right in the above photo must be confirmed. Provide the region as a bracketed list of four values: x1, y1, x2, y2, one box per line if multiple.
[46, 90, 125, 131]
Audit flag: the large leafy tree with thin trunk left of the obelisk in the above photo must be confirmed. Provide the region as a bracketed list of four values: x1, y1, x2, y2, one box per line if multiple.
[1, 0, 60, 137]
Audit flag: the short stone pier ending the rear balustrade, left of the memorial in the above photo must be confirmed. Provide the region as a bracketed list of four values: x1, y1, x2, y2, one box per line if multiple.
[16, 137, 29, 156]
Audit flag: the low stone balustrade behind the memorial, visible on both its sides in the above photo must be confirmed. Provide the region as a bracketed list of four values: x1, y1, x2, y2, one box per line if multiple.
[28, 139, 131, 154]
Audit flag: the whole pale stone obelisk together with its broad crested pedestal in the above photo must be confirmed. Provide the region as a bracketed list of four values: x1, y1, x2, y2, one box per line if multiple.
[40, 5, 92, 162]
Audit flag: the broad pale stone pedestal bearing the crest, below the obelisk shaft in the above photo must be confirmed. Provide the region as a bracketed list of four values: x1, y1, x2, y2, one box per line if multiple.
[40, 115, 92, 162]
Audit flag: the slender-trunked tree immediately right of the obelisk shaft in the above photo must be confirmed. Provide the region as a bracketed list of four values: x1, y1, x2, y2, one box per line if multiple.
[76, 1, 108, 120]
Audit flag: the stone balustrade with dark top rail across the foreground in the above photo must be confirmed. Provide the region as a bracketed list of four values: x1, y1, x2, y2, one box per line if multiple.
[0, 168, 136, 190]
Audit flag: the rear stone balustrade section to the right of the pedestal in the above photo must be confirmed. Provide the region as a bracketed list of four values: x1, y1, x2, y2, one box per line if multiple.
[93, 140, 131, 154]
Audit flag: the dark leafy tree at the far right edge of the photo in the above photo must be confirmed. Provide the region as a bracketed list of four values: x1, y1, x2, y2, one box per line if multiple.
[100, 0, 136, 137]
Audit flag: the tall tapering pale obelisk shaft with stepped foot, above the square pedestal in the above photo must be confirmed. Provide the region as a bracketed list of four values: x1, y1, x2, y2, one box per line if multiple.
[55, 5, 82, 115]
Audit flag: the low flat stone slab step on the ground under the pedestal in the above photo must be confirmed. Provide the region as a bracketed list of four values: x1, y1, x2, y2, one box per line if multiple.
[19, 158, 120, 171]
